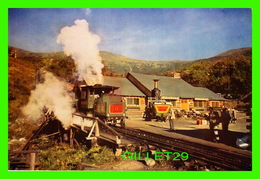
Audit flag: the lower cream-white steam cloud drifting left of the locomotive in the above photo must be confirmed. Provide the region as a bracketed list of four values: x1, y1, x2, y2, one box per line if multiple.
[22, 72, 74, 128]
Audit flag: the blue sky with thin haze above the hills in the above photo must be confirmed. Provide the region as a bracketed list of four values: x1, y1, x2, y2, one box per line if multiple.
[8, 9, 252, 60]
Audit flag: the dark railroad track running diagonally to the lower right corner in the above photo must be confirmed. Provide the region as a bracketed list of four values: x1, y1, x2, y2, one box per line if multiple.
[110, 127, 252, 171]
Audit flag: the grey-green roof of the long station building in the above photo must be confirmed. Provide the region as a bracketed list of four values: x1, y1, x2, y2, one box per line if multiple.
[104, 73, 225, 100]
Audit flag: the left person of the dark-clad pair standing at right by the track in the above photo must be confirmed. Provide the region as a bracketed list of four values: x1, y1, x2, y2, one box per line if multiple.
[209, 107, 220, 142]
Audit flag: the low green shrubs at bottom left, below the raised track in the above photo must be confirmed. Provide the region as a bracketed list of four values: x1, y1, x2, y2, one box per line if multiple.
[39, 144, 115, 170]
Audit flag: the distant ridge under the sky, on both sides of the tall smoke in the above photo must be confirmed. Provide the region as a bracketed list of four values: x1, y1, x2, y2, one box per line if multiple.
[9, 47, 195, 76]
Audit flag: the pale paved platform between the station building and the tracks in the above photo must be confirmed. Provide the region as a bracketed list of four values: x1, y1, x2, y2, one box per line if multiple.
[126, 114, 252, 156]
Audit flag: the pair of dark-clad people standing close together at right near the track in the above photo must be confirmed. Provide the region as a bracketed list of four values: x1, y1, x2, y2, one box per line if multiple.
[208, 107, 236, 143]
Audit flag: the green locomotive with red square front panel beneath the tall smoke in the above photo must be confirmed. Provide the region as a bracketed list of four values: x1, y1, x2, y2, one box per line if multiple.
[74, 82, 126, 127]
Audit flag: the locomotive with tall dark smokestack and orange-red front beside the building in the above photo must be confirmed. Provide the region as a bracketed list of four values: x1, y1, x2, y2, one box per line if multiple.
[144, 79, 172, 122]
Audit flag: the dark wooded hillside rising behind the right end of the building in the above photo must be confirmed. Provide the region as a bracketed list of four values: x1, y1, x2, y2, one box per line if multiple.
[179, 48, 252, 98]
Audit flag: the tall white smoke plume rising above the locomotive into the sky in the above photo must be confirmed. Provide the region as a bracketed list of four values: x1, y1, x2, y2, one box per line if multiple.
[57, 20, 104, 85]
